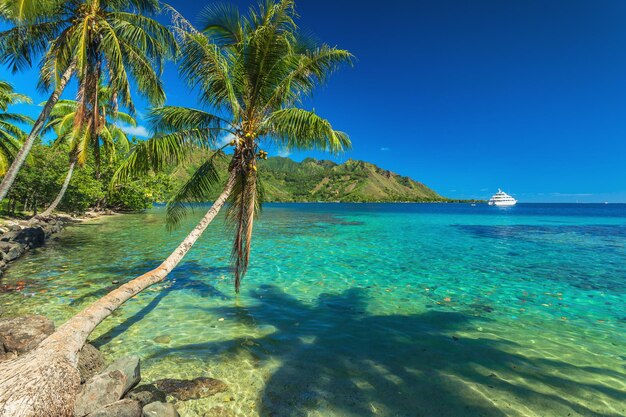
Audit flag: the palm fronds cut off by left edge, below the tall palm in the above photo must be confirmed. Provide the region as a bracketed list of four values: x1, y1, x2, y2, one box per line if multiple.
[0, 81, 33, 175]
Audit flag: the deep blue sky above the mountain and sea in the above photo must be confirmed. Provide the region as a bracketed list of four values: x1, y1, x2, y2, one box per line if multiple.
[0, 0, 626, 202]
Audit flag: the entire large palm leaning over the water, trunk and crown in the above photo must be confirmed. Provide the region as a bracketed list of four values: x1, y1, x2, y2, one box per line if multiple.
[0, 0, 352, 416]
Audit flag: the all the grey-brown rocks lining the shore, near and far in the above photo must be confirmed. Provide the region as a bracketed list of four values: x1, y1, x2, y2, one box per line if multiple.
[0, 212, 233, 417]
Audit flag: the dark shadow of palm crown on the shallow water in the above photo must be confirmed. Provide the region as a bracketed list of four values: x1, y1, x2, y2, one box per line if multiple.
[151, 286, 624, 417]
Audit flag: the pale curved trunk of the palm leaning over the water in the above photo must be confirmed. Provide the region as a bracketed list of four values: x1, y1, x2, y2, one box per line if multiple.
[0, 173, 235, 417]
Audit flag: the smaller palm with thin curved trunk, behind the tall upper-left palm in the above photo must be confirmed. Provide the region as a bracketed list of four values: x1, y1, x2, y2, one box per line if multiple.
[39, 86, 137, 217]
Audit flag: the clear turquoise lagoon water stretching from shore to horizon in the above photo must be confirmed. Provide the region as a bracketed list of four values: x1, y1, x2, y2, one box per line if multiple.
[0, 204, 626, 416]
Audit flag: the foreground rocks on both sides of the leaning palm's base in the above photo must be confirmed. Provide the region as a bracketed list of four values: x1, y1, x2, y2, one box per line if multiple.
[0, 315, 231, 417]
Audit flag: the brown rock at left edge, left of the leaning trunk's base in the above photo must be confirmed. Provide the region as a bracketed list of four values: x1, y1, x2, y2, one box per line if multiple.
[0, 315, 54, 354]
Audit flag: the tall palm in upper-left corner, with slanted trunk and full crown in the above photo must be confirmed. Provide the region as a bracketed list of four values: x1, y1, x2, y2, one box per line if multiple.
[0, 0, 177, 205]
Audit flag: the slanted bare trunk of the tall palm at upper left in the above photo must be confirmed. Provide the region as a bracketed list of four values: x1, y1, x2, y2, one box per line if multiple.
[0, 64, 74, 205]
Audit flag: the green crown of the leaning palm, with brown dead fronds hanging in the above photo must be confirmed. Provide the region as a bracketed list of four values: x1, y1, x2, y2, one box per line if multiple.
[115, 0, 353, 289]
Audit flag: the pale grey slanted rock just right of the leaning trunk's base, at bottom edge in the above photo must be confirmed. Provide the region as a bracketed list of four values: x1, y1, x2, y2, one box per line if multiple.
[74, 370, 126, 417]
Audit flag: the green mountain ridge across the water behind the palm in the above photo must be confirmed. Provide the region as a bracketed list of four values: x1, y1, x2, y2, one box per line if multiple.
[172, 155, 450, 202]
